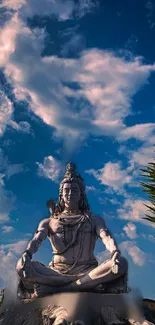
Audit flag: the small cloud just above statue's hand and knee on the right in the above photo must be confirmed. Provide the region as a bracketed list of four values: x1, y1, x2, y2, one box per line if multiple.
[119, 241, 146, 266]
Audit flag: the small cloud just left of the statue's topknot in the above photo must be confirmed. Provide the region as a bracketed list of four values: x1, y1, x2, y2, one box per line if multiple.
[37, 156, 63, 182]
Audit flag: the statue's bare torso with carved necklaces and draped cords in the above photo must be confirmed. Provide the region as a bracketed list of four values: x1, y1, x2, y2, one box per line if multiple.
[48, 214, 97, 265]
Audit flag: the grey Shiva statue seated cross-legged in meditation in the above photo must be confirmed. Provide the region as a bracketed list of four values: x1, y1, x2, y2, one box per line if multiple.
[16, 163, 128, 297]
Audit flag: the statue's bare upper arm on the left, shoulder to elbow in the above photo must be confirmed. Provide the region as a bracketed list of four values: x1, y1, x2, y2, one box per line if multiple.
[26, 219, 49, 258]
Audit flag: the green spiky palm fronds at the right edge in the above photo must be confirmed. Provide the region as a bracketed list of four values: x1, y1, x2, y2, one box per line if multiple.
[140, 157, 155, 222]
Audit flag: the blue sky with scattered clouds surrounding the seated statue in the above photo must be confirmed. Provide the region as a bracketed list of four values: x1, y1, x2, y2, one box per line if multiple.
[0, 0, 155, 298]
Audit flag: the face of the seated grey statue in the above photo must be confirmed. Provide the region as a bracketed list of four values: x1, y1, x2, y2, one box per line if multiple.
[62, 182, 80, 208]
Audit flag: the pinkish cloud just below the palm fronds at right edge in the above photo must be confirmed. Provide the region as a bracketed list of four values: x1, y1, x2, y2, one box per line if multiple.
[117, 199, 155, 227]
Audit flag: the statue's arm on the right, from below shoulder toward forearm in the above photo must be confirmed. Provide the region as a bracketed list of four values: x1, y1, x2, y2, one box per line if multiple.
[96, 217, 119, 255]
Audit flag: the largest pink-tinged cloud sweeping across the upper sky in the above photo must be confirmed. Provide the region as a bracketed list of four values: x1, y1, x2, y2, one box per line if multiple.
[1, 0, 155, 148]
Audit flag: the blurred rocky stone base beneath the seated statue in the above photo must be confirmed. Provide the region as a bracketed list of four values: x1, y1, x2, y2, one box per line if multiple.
[0, 292, 154, 325]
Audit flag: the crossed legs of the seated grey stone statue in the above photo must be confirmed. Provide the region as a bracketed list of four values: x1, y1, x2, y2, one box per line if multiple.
[16, 257, 128, 295]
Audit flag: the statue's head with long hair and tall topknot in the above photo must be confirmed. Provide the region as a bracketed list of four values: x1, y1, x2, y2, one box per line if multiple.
[56, 163, 89, 212]
